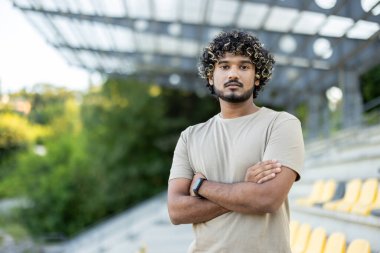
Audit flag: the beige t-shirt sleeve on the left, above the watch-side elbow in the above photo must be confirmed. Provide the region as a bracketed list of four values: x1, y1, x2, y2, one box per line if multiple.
[169, 129, 194, 180]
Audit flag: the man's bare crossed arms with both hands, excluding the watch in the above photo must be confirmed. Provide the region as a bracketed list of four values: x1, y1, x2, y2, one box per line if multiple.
[168, 160, 297, 224]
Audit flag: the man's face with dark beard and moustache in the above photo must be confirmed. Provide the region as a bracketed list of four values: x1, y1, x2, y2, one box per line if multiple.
[209, 53, 259, 103]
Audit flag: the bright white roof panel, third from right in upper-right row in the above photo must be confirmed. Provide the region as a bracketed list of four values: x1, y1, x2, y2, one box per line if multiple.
[292, 11, 326, 34]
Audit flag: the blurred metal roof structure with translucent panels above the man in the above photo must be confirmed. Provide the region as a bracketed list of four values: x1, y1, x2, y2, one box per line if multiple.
[8, 0, 380, 135]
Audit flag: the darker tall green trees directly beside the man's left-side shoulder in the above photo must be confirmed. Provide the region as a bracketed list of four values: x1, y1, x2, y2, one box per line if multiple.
[83, 79, 217, 213]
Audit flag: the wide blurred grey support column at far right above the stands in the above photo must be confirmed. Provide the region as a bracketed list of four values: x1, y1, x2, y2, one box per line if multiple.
[340, 70, 363, 128]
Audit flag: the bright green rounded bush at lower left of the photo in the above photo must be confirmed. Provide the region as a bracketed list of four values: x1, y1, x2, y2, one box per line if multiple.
[14, 133, 104, 235]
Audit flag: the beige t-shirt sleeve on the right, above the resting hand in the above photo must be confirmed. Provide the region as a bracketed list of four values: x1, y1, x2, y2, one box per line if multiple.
[263, 113, 305, 181]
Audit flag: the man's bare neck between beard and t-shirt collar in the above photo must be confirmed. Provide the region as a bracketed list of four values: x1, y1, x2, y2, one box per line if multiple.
[219, 99, 260, 119]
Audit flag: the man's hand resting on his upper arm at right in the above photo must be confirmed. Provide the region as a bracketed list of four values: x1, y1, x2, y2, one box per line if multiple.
[246, 160, 281, 184]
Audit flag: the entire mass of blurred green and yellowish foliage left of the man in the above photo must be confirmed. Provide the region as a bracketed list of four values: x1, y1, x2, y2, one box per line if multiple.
[0, 79, 218, 239]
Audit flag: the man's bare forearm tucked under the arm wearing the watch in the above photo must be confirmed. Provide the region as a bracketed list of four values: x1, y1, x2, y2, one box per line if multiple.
[168, 196, 229, 225]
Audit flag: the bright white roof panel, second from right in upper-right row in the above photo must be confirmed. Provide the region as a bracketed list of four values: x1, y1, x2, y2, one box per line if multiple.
[319, 15, 354, 37]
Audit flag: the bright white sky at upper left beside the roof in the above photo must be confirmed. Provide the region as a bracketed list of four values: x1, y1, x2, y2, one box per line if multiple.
[0, 0, 100, 94]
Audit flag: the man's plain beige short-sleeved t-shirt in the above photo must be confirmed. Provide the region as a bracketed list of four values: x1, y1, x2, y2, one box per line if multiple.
[169, 107, 304, 253]
